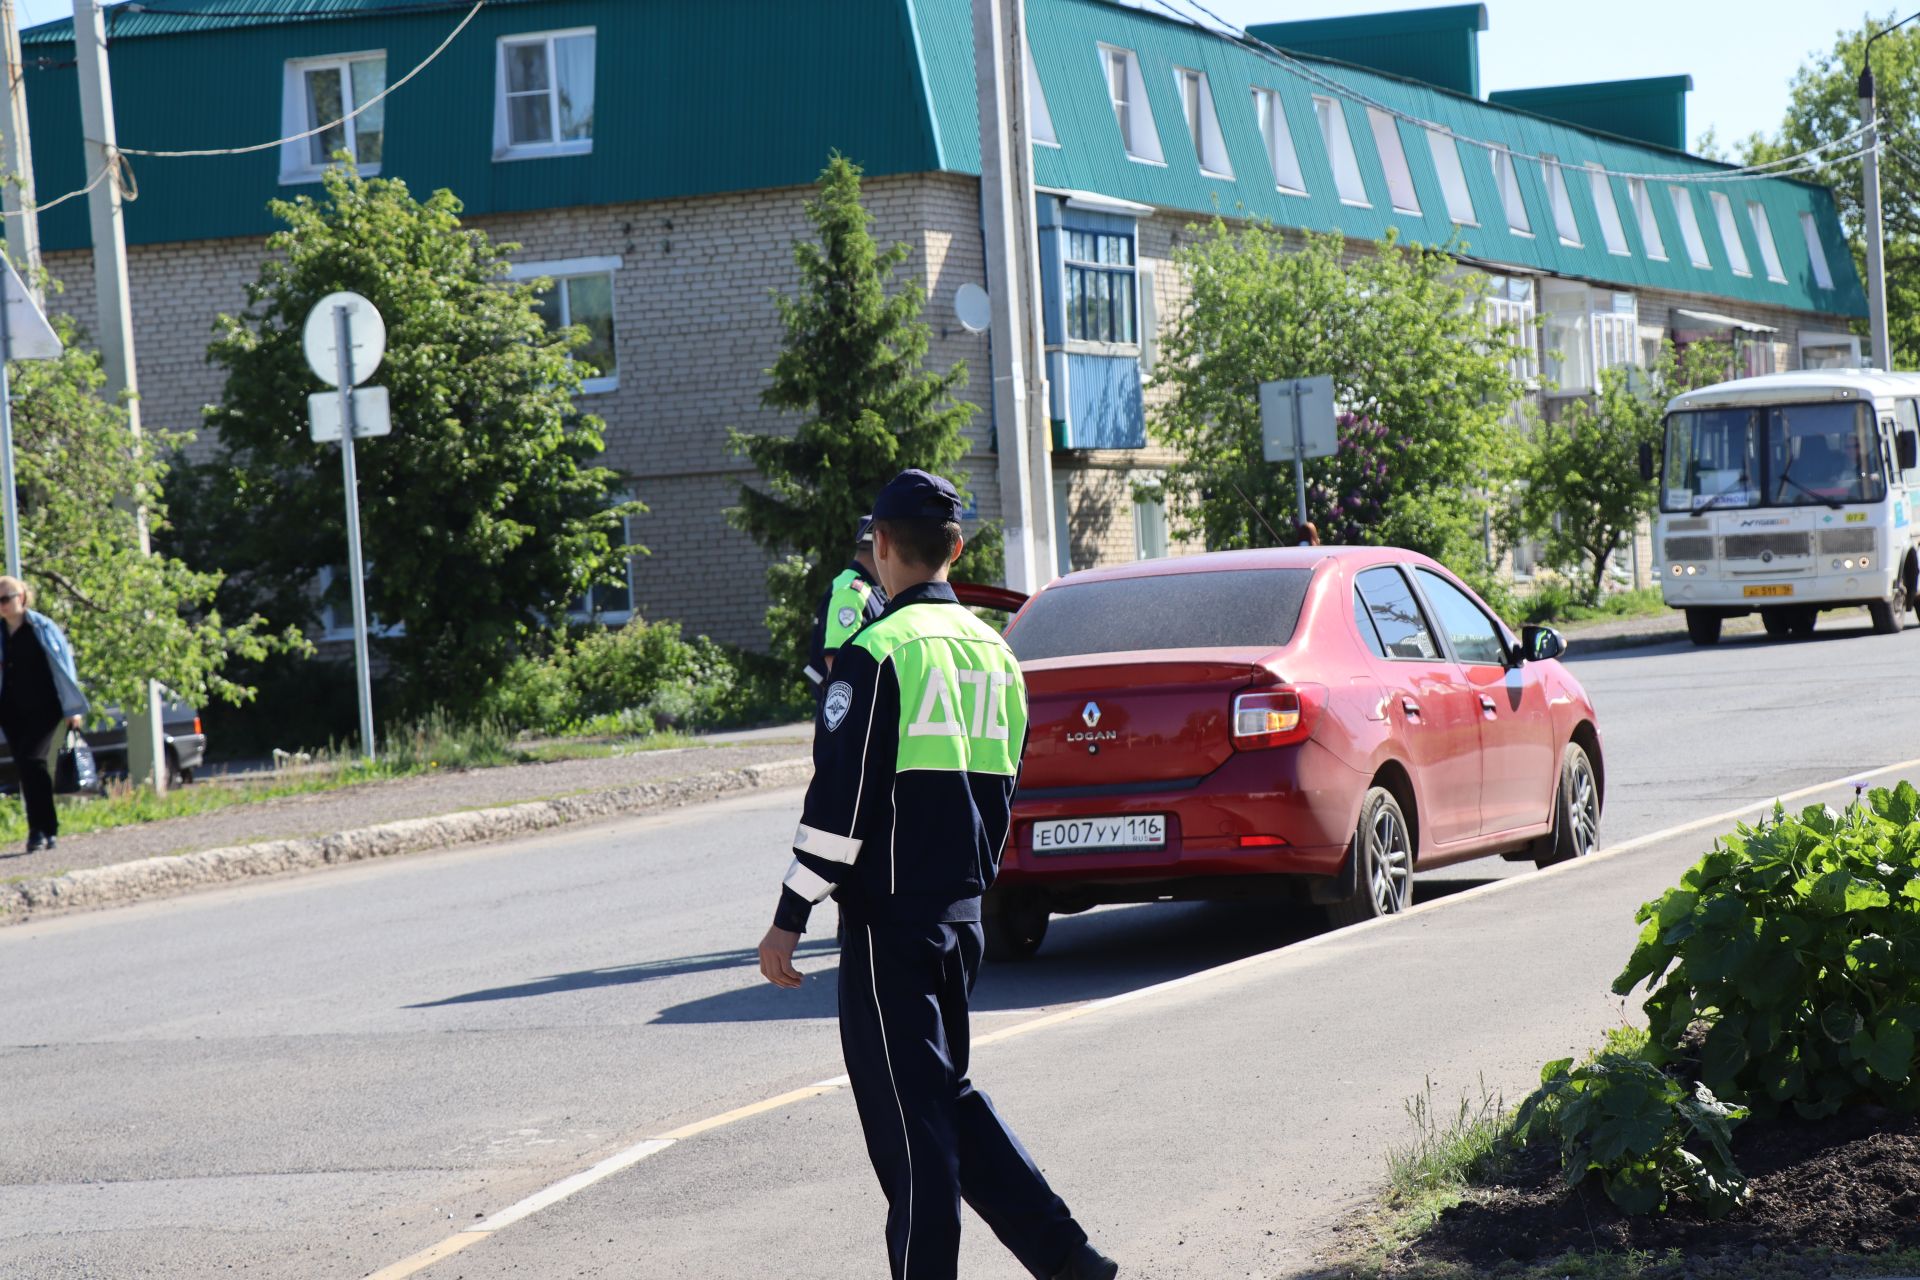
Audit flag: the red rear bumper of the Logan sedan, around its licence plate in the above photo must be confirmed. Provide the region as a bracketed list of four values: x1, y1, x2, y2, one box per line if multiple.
[996, 741, 1367, 889]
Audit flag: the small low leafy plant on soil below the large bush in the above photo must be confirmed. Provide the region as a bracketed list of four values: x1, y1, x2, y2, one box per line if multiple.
[1513, 1050, 1747, 1217]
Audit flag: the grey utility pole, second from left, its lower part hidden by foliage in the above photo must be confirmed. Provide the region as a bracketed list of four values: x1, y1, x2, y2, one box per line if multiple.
[73, 0, 167, 793]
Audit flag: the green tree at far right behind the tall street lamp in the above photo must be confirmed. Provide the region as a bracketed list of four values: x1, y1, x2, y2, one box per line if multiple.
[1734, 12, 1920, 368]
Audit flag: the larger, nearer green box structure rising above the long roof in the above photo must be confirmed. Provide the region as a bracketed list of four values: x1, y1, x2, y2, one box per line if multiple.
[1246, 4, 1486, 98]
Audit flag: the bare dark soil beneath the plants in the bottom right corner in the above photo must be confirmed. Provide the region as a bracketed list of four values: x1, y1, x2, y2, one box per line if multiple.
[1415, 1107, 1920, 1267]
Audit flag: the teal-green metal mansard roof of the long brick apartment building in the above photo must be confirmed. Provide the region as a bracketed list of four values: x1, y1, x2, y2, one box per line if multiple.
[15, 0, 1866, 315]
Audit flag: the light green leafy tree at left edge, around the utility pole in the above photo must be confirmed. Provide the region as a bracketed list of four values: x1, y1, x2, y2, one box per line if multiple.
[10, 315, 305, 706]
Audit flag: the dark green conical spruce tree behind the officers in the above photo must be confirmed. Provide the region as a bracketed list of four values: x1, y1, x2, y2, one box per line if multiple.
[728, 155, 996, 672]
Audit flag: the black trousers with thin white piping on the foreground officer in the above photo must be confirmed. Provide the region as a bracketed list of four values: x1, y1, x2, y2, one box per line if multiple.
[839, 921, 1087, 1280]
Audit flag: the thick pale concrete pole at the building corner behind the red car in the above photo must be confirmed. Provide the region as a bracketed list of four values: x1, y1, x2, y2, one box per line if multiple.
[973, 0, 1056, 595]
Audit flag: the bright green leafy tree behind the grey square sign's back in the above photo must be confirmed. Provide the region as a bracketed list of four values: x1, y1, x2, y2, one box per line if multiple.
[1148, 219, 1521, 581]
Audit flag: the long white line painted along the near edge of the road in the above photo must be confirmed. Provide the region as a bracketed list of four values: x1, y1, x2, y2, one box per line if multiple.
[367, 760, 1920, 1280]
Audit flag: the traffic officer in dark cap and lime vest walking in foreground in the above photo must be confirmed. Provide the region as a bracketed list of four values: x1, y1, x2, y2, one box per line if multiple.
[760, 470, 1119, 1280]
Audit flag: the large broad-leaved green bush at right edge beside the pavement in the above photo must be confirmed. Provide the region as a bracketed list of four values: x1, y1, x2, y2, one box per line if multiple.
[1613, 783, 1920, 1119]
